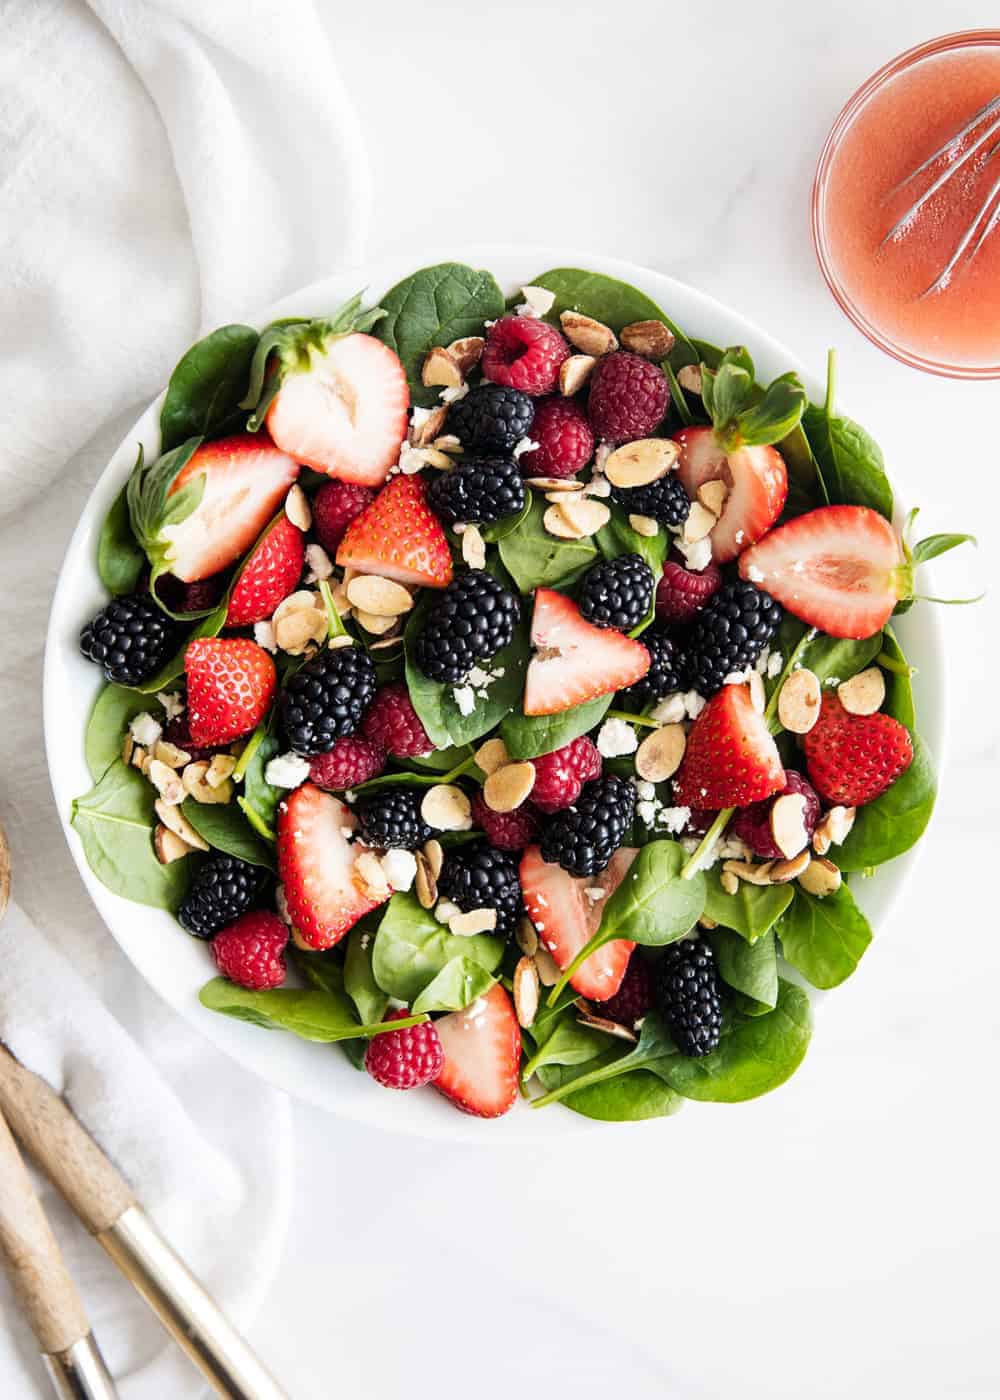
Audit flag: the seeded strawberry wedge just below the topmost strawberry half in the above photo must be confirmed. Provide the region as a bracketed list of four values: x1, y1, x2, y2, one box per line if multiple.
[336, 476, 452, 588]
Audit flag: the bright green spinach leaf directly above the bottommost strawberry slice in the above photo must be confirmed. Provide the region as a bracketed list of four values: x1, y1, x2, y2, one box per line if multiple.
[371, 893, 504, 1011]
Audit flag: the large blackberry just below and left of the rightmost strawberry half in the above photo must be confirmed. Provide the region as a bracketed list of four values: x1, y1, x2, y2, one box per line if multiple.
[685, 580, 782, 696]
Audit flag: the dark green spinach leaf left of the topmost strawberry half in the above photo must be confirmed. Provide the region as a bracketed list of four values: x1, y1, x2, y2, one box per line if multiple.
[160, 325, 259, 452]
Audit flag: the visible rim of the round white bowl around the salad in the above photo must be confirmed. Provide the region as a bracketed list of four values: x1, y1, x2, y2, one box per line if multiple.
[43, 245, 944, 1142]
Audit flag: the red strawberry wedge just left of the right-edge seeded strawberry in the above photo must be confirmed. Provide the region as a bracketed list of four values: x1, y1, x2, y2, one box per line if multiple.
[674, 685, 784, 812]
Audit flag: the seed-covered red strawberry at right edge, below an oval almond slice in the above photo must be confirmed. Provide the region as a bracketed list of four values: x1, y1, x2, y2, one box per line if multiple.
[803, 690, 913, 806]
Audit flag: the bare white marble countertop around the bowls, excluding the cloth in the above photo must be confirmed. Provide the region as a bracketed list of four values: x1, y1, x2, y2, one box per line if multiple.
[245, 0, 1000, 1400]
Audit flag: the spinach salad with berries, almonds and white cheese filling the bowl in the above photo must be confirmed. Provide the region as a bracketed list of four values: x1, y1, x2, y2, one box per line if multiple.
[73, 263, 966, 1121]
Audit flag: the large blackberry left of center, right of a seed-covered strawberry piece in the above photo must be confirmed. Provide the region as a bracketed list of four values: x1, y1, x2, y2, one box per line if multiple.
[282, 647, 375, 759]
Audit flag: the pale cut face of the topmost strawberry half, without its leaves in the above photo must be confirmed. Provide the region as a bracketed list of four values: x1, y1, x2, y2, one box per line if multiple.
[268, 333, 410, 486]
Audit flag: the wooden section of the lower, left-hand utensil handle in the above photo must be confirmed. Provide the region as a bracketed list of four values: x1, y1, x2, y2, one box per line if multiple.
[0, 1117, 90, 1352]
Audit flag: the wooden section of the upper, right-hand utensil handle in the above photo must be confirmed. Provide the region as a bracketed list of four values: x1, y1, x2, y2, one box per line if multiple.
[0, 1046, 136, 1235]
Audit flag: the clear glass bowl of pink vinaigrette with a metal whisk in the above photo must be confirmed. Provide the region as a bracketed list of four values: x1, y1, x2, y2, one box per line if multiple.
[814, 31, 1000, 378]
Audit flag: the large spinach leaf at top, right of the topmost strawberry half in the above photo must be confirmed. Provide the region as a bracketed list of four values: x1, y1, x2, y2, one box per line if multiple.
[374, 263, 504, 407]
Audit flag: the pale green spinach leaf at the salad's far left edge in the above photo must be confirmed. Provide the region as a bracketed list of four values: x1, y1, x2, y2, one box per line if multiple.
[71, 759, 189, 910]
